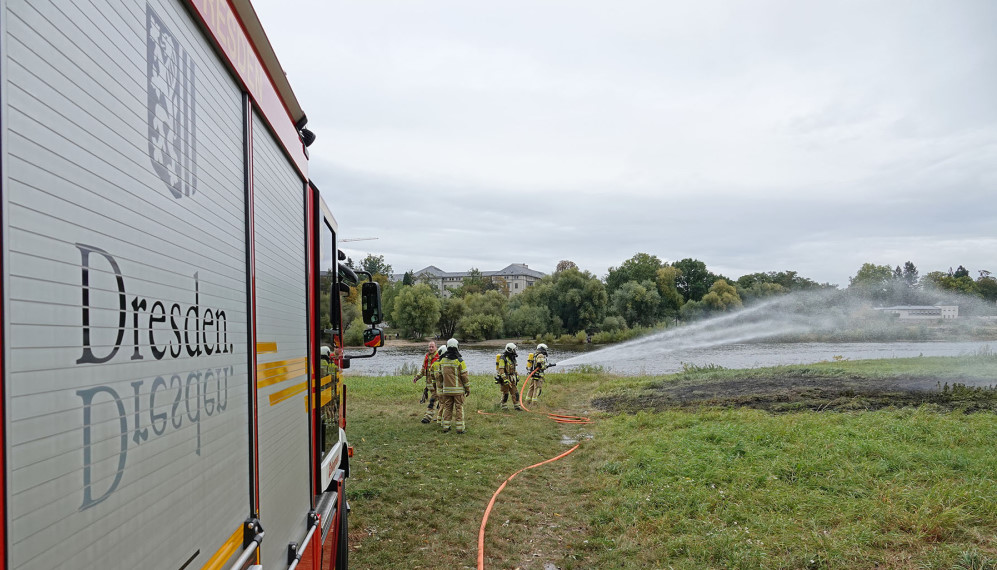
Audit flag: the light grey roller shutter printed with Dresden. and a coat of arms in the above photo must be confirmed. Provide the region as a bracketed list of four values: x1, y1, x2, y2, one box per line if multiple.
[0, 0, 249, 570]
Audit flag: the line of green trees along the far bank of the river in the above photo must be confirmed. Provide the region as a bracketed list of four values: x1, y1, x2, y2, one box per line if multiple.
[343, 253, 997, 344]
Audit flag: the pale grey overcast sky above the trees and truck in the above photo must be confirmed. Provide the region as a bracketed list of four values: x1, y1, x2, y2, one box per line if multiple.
[254, 0, 997, 286]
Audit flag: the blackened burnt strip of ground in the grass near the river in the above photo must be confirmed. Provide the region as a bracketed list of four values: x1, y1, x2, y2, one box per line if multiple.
[593, 370, 997, 412]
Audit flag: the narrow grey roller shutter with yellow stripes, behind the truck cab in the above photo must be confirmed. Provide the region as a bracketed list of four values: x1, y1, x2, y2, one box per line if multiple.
[253, 108, 311, 568]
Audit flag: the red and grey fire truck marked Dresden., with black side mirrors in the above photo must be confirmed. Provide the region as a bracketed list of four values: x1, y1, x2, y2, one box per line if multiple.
[0, 0, 383, 570]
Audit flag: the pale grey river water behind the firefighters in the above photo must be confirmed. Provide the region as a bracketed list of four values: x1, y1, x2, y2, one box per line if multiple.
[346, 341, 991, 376]
